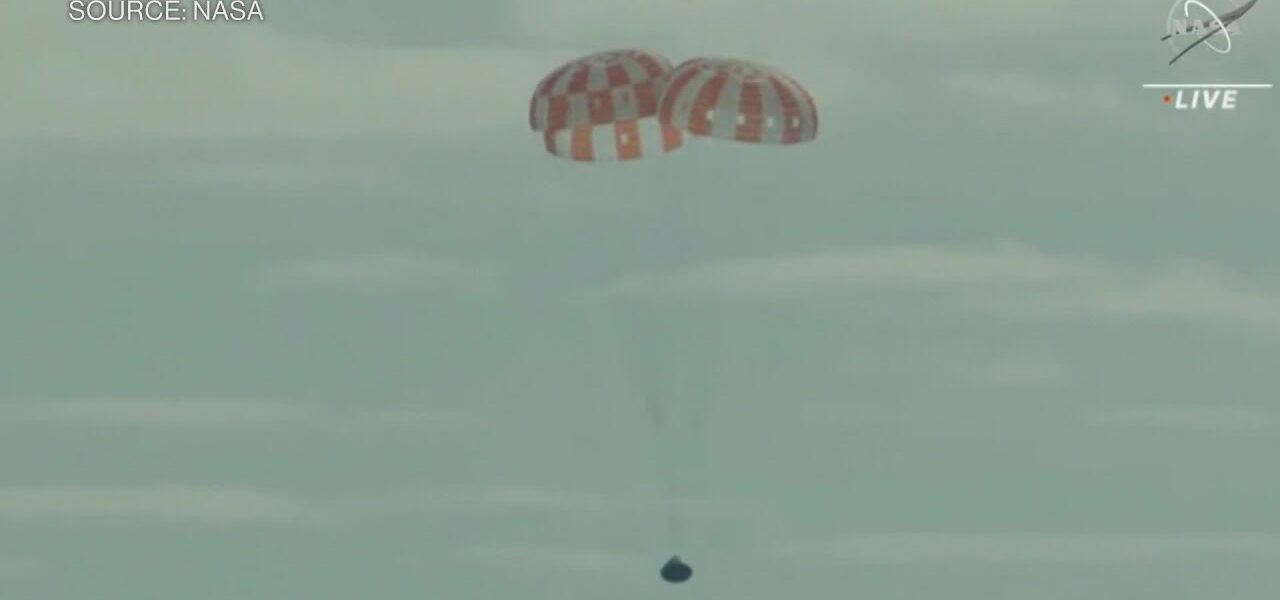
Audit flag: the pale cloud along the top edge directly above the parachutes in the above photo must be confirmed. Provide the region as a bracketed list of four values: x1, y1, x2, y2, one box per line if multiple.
[513, 0, 1080, 53]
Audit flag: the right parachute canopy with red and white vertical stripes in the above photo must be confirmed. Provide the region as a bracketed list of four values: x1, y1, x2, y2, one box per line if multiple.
[658, 58, 818, 145]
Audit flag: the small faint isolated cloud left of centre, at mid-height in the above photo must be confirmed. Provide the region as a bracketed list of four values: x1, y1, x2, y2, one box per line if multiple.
[273, 253, 475, 288]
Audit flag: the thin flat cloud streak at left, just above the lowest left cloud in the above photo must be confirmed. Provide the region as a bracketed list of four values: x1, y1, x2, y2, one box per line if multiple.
[18, 398, 310, 426]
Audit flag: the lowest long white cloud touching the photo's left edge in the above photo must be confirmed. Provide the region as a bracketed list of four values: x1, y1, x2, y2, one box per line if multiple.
[0, 485, 324, 522]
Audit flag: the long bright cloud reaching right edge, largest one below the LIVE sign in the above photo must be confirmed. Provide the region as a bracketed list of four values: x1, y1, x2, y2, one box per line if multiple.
[620, 242, 1280, 335]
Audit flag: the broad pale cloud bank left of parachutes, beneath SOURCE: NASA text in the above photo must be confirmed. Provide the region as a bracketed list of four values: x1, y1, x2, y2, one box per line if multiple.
[0, 1, 548, 148]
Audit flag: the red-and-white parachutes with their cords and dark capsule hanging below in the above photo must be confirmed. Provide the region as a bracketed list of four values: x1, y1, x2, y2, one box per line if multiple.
[529, 50, 818, 583]
